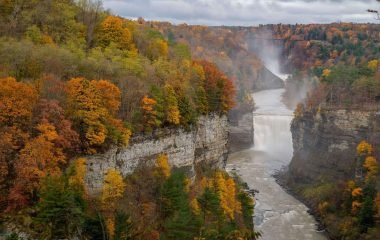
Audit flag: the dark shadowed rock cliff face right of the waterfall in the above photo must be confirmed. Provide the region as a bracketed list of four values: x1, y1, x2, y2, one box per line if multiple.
[288, 110, 380, 183]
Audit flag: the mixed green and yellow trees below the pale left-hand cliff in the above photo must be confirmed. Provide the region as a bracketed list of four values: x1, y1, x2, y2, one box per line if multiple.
[2, 154, 259, 240]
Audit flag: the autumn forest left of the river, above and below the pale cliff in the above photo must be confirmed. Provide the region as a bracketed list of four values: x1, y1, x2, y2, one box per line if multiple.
[0, 0, 255, 240]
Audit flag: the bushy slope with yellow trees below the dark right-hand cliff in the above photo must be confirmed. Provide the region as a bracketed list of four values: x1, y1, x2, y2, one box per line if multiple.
[297, 141, 380, 239]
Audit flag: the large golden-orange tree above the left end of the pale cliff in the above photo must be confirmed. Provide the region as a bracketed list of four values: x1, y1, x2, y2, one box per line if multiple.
[67, 78, 131, 153]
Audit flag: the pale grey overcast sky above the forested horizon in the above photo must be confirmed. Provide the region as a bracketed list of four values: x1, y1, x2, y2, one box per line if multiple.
[104, 0, 380, 26]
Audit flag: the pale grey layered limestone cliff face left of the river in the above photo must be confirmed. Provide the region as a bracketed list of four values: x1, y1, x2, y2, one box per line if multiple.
[86, 115, 228, 194]
